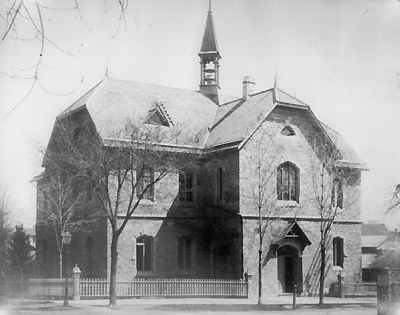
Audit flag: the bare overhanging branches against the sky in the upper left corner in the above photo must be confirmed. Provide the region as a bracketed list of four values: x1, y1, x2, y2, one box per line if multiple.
[0, 0, 129, 123]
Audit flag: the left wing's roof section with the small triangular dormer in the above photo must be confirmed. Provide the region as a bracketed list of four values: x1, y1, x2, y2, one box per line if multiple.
[57, 78, 217, 147]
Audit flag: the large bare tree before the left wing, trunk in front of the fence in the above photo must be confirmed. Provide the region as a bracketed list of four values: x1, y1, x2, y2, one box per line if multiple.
[44, 113, 200, 306]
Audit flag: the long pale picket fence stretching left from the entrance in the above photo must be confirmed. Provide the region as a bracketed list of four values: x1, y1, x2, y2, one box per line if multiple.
[0, 277, 249, 300]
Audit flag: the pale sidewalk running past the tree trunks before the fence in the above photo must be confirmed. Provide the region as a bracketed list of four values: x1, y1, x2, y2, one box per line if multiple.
[0, 295, 376, 312]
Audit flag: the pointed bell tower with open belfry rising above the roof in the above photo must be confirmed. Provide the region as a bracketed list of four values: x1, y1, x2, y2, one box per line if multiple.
[199, 0, 221, 105]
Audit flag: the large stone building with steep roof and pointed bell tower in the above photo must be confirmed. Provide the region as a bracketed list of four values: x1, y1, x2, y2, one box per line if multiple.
[37, 6, 366, 294]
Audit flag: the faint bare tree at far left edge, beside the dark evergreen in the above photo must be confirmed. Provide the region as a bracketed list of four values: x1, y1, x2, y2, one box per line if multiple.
[0, 181, 18, 277]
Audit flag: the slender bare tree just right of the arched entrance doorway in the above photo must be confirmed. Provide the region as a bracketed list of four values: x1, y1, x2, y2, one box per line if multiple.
[309, 133, 361, 304]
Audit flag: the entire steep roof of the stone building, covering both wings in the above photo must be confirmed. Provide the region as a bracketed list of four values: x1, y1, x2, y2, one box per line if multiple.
[57, 78, 367, 169]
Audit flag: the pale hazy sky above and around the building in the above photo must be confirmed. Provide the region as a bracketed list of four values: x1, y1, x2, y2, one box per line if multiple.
[0, 0, 400, 228]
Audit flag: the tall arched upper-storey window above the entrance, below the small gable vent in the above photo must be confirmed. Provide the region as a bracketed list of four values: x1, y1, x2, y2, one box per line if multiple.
[277, 162, 300, 202]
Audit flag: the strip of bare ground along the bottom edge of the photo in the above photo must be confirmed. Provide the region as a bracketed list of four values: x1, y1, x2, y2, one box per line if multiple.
[0, 299, 376, 315]
